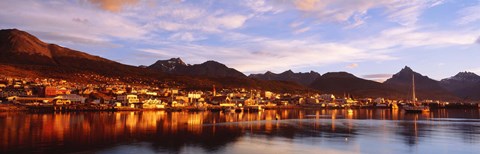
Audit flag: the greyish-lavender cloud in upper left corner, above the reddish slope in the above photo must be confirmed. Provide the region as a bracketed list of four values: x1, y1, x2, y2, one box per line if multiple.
[0, 0, 147, 44]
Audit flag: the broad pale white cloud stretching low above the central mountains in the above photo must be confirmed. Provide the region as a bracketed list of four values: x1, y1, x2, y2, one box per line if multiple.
[139, 33, 394, 72]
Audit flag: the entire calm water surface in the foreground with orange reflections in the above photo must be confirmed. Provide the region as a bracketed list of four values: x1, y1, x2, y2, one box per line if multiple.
[0, 109, 480, 154]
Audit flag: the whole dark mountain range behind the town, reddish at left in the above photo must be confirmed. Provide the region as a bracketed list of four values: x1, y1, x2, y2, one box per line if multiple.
[0, 29, 480, 100]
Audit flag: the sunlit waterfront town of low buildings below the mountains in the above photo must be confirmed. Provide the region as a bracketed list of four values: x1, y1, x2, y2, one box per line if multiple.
[0, 77, 480, 112]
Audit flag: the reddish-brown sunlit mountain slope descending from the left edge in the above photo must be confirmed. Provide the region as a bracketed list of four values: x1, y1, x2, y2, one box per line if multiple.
[0, 29, 161, 76]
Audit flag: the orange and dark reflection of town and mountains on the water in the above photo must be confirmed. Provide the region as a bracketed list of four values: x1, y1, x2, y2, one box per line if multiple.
[0, 109, 480, 153]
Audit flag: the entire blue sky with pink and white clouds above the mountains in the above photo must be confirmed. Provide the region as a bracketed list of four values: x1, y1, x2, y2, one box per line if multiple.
[0, 0, 480, 81]
